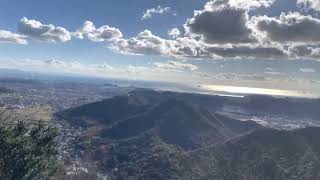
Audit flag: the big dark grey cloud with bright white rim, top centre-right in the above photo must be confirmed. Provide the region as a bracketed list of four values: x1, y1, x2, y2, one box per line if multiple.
[185, 0, 254, 44]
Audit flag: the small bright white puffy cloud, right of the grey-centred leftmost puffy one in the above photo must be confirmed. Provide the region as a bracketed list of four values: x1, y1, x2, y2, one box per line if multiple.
[74, 21, 122, 42]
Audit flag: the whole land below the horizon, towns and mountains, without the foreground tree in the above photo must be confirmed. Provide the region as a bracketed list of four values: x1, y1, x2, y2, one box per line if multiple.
[0, 76, 320, 180]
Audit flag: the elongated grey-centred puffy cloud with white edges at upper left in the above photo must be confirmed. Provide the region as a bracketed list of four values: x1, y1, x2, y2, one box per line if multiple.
[18, 17, 71, 42]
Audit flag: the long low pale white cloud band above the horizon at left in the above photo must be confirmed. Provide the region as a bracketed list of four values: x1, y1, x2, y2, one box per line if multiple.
[0, 59, 197, 81]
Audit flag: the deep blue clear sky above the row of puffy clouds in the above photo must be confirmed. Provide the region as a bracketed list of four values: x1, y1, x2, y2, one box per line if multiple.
[0, 0, 205, 36]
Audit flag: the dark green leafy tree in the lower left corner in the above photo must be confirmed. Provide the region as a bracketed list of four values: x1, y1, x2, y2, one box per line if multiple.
[0, 121, 58, 180]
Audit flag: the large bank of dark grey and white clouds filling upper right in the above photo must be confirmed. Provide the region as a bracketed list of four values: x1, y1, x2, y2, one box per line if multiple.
[112, 0, 320, 59]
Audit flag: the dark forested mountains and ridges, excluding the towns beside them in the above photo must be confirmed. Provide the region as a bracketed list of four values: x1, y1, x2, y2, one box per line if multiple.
[57, 89, 320, 180]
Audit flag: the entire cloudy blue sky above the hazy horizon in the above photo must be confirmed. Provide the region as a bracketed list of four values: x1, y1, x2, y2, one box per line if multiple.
[0, 0, 320, 96]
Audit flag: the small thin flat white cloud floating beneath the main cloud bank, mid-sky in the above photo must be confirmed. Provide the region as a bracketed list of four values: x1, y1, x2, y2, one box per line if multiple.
[154, 61, 198, 71]
